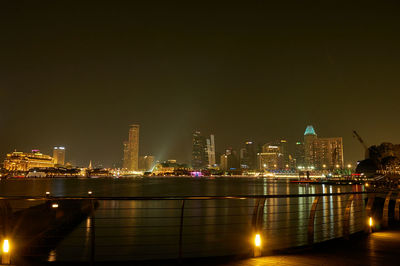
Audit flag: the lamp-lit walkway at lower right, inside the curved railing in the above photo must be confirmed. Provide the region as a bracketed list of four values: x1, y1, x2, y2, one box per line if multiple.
[222, 230, 400, 266]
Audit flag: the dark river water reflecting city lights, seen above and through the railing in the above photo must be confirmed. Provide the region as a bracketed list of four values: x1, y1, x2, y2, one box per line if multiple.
[0, 177, 365, 261]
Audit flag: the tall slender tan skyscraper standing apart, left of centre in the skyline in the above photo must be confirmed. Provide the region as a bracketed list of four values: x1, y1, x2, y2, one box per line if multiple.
[123, 124, 140, 171]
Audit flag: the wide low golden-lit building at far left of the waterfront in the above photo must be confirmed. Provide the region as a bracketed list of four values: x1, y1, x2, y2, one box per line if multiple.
[4, 150, 54, 171]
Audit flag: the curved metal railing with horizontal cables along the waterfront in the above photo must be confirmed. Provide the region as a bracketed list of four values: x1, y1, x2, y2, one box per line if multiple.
[0, 192, 400, 264]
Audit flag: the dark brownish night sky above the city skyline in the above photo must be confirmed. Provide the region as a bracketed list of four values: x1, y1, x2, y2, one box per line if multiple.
[0, 0, 400, 166]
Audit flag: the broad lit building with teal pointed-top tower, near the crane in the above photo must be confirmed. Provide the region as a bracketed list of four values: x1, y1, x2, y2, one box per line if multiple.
[304, 126, 344, 170]
